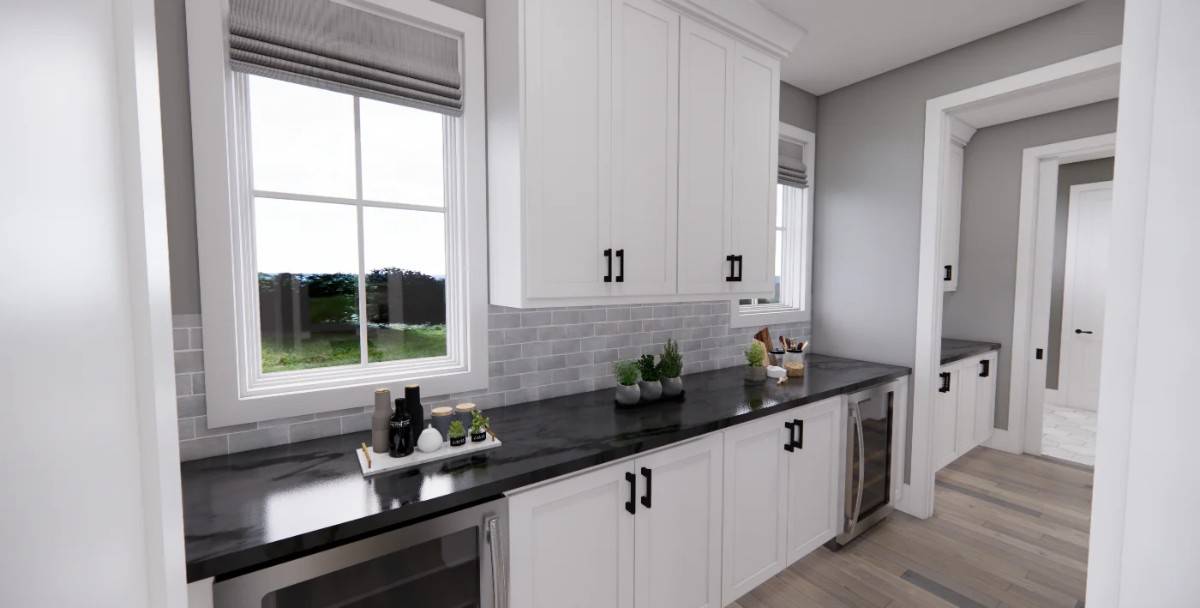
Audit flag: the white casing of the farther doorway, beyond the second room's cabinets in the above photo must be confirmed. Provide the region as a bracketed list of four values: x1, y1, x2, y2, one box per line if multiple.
[988, 133, 1116, 453]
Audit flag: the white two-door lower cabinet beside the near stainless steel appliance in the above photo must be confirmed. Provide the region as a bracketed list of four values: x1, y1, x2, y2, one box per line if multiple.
[509, 434, 722, 608]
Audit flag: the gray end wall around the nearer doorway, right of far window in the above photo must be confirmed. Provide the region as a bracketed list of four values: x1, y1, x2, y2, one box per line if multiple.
[812, 0, 1123, 366]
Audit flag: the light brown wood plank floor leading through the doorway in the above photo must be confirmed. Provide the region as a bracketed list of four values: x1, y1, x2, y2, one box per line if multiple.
[732, 447, 1092, 608]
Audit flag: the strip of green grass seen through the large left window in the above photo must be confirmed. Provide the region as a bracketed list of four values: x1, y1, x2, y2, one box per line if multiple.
[263, 325, 446, 373]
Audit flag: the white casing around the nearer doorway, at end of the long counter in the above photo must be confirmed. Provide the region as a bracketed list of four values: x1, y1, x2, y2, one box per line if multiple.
[900, 47, 1121, 518]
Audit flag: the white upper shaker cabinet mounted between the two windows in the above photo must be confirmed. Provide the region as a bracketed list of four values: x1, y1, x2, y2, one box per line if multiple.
[486, 0, 780, 307]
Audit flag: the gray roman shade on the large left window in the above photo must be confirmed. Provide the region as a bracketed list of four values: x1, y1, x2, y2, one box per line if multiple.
[229, 0, 462, 115]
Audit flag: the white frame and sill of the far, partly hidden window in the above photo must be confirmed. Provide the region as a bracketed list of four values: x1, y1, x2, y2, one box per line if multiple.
[730, 122, 817, 327]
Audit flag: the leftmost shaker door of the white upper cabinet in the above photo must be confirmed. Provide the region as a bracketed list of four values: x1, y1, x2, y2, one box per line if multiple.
[520, 0, 612, 297]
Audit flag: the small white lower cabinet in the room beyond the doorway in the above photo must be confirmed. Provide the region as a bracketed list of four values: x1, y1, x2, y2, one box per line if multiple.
[934, 351, 997, 469]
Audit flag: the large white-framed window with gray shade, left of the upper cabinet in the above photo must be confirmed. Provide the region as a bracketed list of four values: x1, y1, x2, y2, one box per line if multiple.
[188, 0, 487, 427]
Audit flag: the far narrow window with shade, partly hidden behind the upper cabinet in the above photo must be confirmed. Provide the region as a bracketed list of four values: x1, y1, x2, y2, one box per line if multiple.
[730, 124, 816, 327]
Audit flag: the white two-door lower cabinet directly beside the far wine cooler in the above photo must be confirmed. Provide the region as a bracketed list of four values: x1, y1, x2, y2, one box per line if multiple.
[721, 397, 845, 604]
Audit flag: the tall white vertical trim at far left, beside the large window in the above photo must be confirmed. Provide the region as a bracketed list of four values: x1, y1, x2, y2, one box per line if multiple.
[112, 0, 187, 608]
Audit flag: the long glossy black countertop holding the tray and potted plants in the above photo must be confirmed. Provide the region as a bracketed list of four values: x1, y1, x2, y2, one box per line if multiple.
[182, 355, 910, 582]
